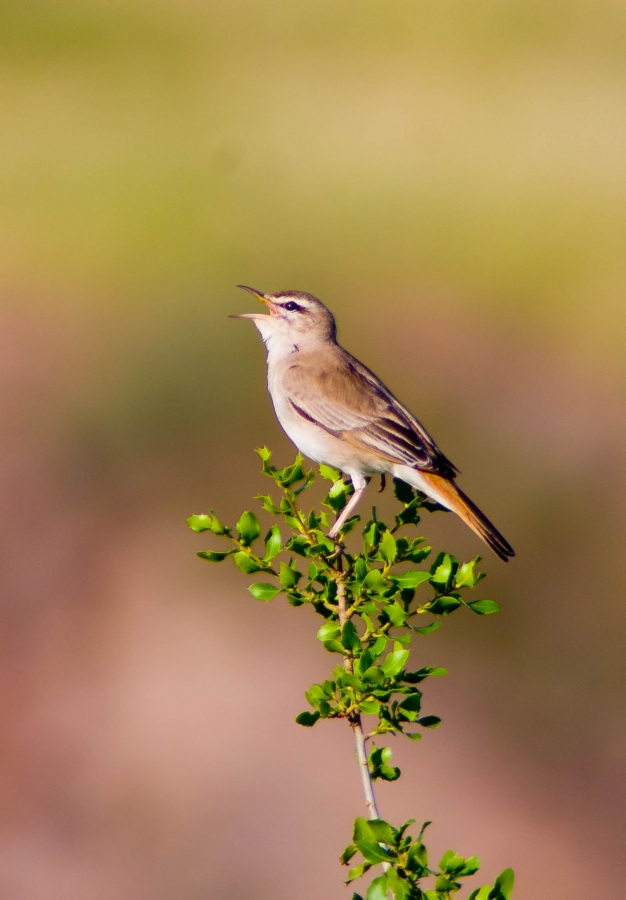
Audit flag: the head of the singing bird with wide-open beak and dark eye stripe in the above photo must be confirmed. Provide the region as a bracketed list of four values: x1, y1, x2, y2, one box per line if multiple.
[233, 284, 336, 346]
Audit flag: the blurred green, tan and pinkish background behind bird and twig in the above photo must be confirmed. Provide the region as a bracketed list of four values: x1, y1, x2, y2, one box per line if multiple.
[0, 0, 626, 900]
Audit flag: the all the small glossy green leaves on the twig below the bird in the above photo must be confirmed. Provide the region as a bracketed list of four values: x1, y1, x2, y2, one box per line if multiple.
[187, 448, 512, 900]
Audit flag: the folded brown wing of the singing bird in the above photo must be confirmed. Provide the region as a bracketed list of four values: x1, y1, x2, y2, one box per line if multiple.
[283, 347, 456, 478]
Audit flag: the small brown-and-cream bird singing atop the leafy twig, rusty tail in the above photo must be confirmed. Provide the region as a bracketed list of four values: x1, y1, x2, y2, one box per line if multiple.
[231, 284, 515, 562]
